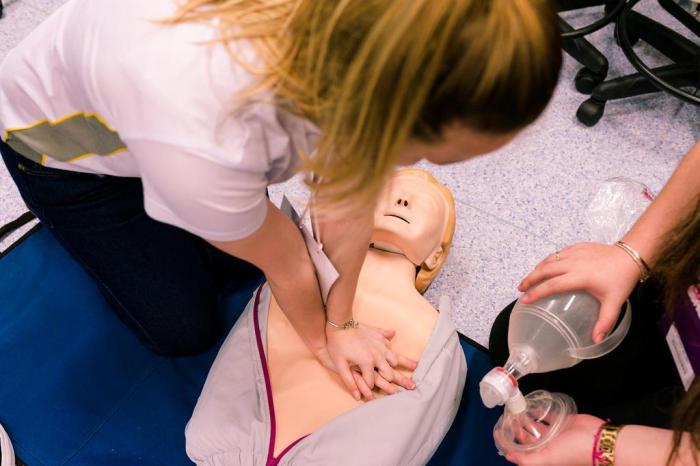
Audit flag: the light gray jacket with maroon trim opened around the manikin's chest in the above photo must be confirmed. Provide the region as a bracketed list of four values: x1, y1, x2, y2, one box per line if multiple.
[185, 285, 467, 466]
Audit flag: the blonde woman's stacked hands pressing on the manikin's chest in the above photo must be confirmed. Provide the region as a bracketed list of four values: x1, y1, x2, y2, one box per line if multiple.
[321, 325, 417, 400]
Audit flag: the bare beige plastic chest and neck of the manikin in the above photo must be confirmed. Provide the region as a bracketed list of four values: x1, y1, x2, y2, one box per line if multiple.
[267, 249, 438, 455]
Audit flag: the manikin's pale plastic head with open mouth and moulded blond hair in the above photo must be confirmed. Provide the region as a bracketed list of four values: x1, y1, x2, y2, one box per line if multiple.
[371, 174, 449, 269]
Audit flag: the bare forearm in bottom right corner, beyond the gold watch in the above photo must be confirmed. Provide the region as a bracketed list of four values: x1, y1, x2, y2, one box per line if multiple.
[615, 425, 695, 466]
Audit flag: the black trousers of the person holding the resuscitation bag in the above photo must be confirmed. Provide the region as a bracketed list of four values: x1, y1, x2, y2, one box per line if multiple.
[489, 281, 684, 427]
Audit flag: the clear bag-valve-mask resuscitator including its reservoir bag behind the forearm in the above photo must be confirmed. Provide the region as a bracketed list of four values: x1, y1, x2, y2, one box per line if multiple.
[480, 178, 654, 453]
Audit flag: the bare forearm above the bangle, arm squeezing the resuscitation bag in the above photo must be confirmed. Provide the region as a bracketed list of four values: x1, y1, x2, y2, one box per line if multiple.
[623, 143, 700, 266]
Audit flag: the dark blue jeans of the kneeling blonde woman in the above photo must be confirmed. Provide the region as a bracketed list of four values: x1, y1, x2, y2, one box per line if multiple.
[0, 141, 262, 356]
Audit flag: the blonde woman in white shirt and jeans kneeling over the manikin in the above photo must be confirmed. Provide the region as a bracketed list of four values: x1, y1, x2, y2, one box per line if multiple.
[0, 0, 561, 399]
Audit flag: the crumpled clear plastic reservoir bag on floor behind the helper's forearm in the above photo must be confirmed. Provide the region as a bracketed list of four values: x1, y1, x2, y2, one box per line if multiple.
[586, 177, 654, 243]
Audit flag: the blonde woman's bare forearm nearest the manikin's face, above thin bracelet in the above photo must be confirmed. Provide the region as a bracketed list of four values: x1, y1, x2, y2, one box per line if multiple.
[320, 206, 374, 322]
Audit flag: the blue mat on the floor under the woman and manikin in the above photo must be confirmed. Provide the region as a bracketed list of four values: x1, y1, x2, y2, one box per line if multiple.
[0, 227, 508, 466]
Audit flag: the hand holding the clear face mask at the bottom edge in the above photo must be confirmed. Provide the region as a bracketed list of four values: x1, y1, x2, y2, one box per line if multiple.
[497, 414, 603, 466]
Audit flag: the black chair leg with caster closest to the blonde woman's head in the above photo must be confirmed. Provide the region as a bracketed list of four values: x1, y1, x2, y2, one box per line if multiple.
[559, 19, 608, 94]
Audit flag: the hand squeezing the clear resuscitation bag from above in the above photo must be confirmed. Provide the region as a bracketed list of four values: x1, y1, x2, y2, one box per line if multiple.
[518, 243, 641, 343]
